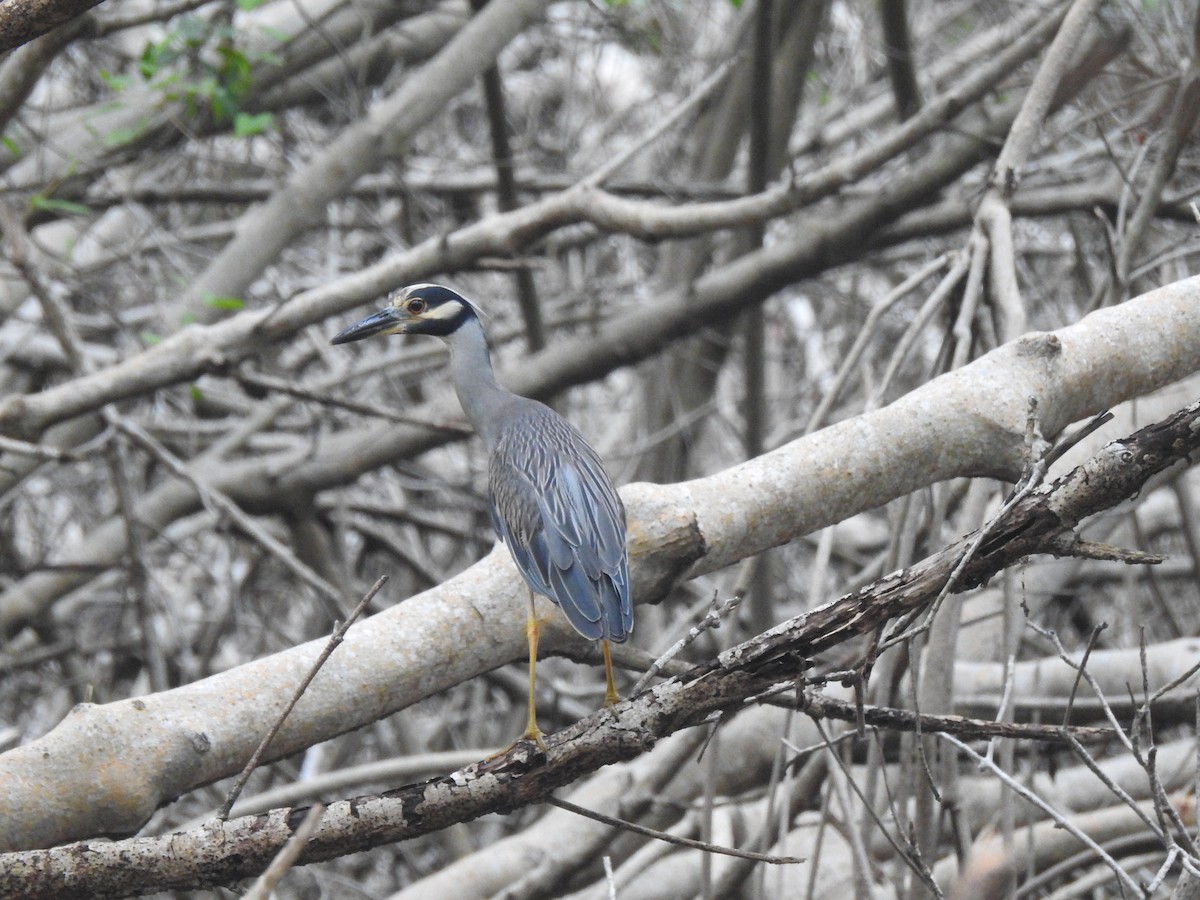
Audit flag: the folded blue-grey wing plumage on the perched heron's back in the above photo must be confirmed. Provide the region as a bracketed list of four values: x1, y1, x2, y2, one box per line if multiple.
[490, 401, 634, 642]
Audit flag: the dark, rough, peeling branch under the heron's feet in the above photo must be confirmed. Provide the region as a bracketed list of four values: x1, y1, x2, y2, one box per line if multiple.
[0, 402, 1200, 899]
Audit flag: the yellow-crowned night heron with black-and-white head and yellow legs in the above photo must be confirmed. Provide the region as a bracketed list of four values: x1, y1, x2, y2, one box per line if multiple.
[334, 284, 634, 744]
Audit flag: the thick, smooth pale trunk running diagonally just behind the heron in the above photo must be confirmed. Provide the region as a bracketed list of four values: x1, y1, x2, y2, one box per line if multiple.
[0, 278, 1200, 847]
